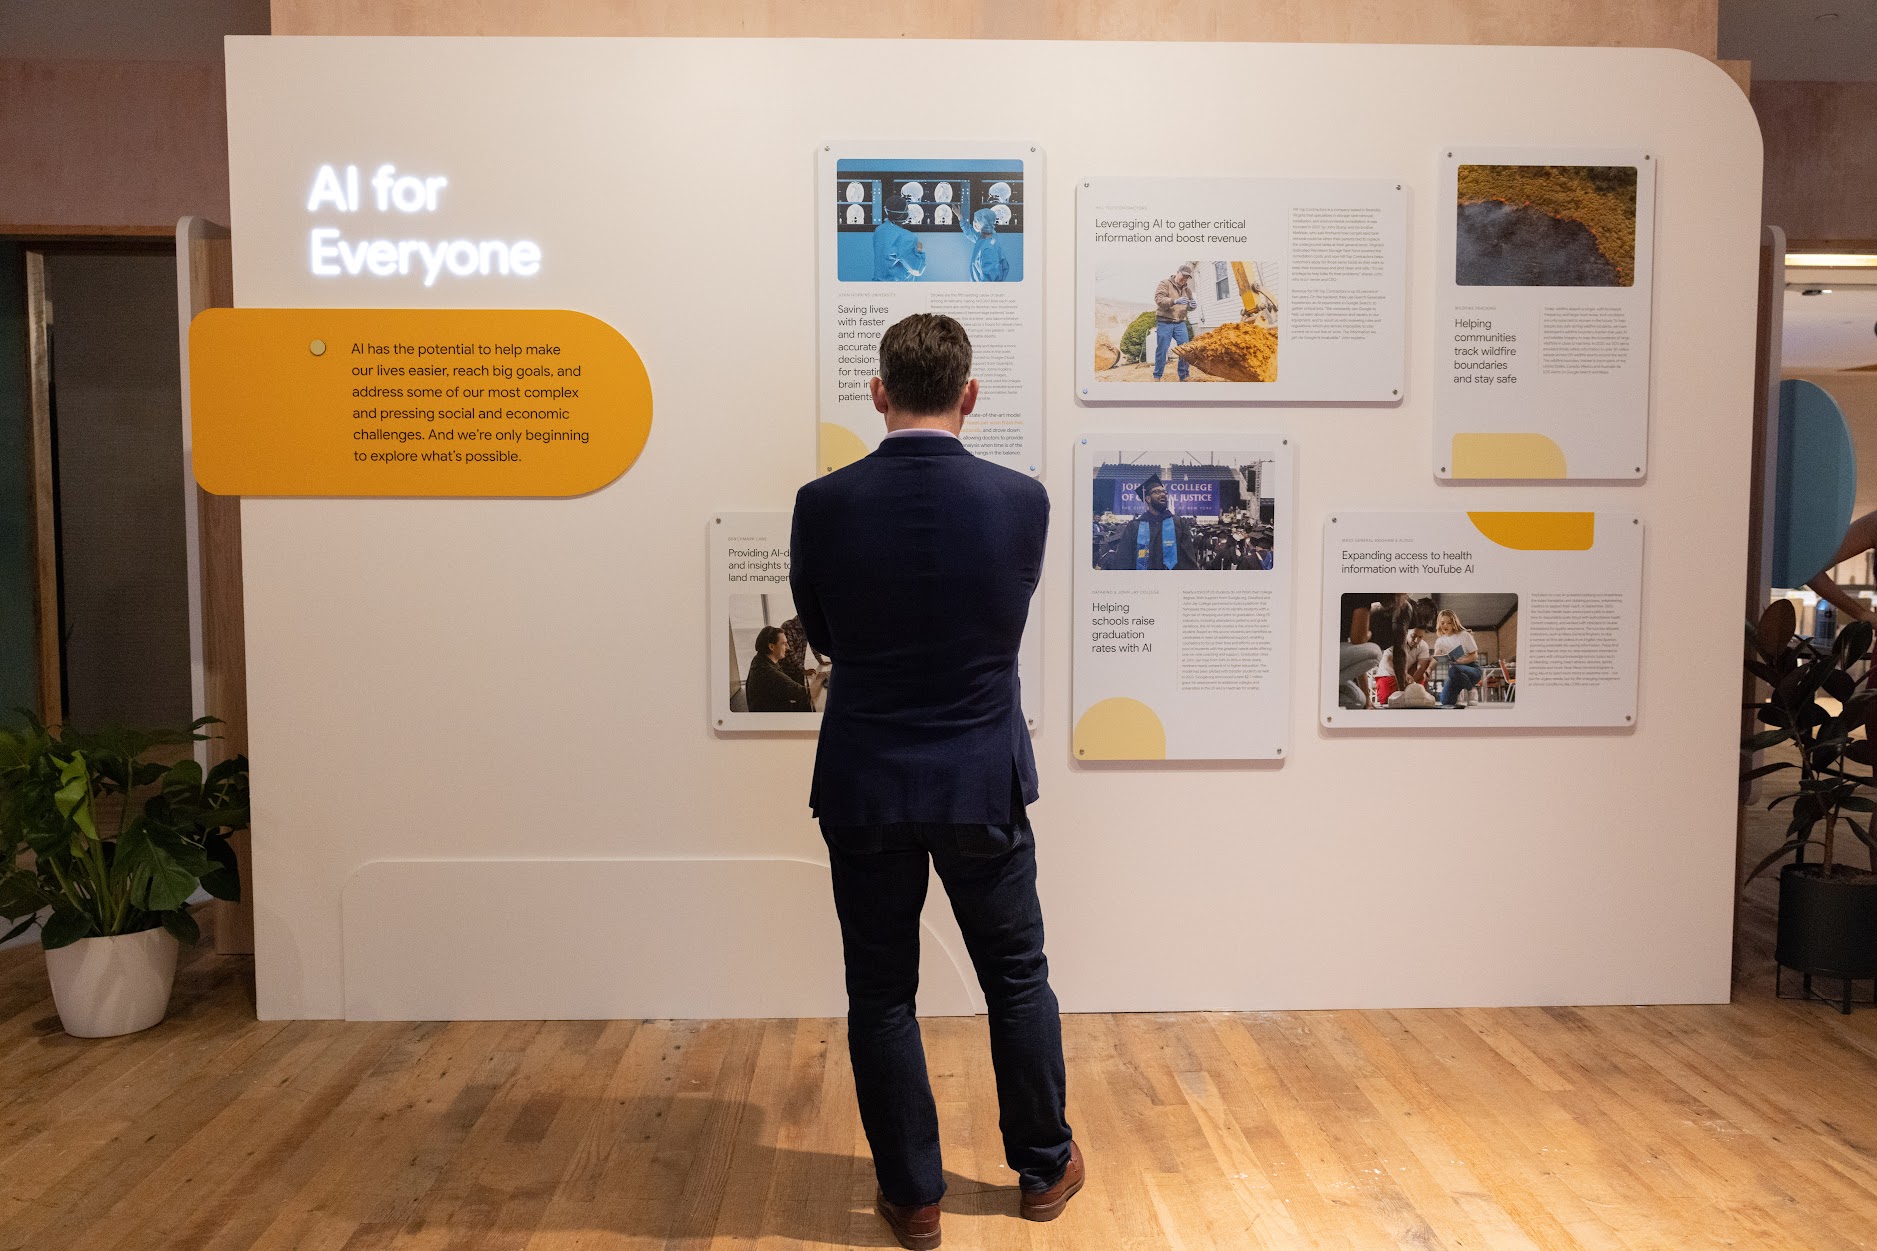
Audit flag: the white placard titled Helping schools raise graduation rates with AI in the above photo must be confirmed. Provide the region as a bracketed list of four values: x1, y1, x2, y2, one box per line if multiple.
[1070, 432, 1293, 763]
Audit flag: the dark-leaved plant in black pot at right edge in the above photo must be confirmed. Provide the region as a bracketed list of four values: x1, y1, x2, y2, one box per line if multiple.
[1740, 599, 1877, 1012]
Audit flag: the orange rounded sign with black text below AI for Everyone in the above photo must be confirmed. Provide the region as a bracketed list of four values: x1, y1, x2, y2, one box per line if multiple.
[190, 308, 651, 498]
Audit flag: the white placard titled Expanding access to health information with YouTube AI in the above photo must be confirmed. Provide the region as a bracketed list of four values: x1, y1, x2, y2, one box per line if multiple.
[1318, 513, 1642, 731]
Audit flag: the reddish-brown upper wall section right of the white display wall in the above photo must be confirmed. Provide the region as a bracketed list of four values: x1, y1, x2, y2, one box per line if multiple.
[1751, 83, 1877, 248]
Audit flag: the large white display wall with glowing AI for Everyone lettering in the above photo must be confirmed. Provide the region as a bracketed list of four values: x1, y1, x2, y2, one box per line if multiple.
[227, 38, 1761, 1018]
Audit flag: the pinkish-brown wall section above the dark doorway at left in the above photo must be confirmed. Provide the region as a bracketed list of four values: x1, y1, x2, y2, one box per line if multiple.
[0, 60, 229, 235]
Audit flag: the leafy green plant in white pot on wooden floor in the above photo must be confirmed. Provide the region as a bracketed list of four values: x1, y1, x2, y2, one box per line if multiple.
[0, 716, 248, 1039]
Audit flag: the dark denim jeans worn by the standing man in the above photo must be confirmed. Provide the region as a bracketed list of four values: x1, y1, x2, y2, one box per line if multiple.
[822, 821, 1070, 1206]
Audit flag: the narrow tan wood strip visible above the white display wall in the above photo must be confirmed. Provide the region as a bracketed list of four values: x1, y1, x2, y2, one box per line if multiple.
[272, 0, 1719, 56]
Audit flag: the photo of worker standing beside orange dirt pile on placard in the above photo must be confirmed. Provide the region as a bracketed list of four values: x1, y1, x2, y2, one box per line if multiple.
[1094, 257, 1278, 383]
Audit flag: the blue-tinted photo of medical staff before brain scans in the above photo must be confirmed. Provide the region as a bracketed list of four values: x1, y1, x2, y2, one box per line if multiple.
[835, 160, 1023, 282]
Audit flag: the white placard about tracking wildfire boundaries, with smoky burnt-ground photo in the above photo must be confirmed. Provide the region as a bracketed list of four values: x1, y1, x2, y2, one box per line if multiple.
[1434, 147, 1659, 479]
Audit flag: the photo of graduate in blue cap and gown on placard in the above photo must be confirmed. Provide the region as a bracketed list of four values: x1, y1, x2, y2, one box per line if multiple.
[1091, 451, 1276, 571]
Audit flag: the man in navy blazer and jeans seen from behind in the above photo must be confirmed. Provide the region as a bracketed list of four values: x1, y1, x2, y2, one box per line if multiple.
[788, 314, 1083, 1249]
